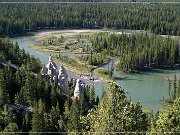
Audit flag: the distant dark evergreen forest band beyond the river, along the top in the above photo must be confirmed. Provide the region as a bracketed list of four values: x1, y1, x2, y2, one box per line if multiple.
[0, 3, 180, 36]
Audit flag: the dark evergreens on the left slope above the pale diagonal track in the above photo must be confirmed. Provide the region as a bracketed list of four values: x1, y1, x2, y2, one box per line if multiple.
[0, 38, 41, 73]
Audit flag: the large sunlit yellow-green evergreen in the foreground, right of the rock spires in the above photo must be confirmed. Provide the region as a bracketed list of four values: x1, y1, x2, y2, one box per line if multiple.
[82, 83, 148, 133]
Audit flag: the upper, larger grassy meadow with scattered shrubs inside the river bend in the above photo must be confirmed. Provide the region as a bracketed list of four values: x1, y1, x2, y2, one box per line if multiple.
[33, 32, 89, 53]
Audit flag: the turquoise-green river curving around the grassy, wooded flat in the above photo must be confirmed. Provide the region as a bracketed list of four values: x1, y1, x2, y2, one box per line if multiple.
[11, 29, 180, 112]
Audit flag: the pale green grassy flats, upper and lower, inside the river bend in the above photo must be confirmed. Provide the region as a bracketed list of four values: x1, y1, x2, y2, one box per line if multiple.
[30, 32, 112, 82]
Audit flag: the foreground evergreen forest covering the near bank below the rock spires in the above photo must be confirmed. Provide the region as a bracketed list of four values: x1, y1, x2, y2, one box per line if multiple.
[0, 39, 180, 134]
